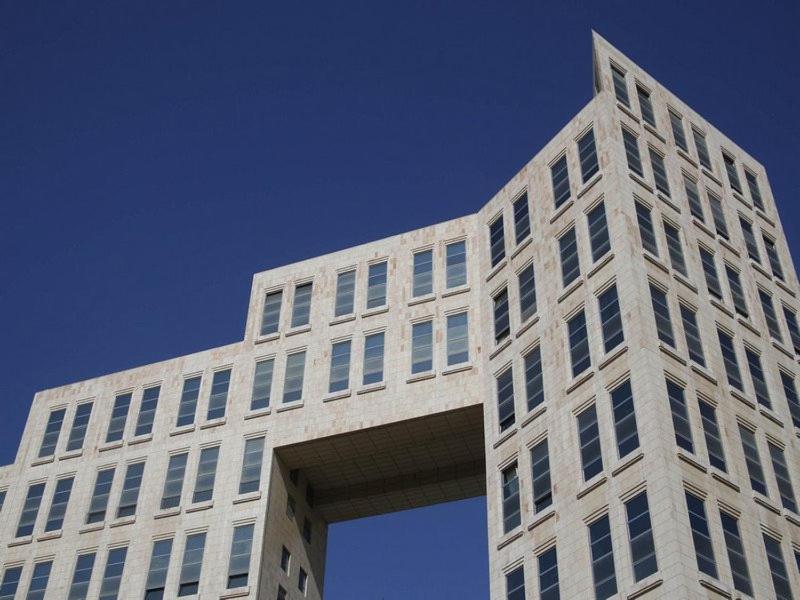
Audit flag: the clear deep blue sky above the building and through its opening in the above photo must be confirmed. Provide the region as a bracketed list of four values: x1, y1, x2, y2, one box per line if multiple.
[0, 0, 800, 600]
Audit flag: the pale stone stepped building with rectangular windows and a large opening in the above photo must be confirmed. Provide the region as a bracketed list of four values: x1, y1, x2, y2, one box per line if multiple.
[0, 35, 800, 600]
